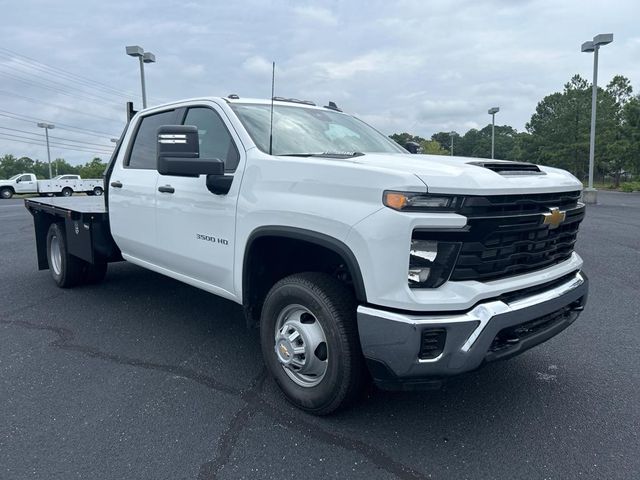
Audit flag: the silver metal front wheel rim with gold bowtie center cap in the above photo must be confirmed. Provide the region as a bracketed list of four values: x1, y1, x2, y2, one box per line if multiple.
[274, 305, 329, 387]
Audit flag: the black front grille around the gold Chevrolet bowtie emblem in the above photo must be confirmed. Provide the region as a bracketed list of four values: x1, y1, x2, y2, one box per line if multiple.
[413, 191, 585, 281]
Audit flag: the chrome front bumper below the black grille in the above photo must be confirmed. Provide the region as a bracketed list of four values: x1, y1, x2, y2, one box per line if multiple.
[358, 272, 588, 389]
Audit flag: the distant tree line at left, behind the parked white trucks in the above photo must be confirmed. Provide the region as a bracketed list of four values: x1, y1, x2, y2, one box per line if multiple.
[0, 154, 107, 179]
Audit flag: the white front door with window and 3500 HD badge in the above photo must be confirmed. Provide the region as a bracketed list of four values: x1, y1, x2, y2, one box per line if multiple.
[156, 106, 240, 298]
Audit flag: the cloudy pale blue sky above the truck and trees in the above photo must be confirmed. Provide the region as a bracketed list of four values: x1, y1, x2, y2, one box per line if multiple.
[0, 0, 640, 164]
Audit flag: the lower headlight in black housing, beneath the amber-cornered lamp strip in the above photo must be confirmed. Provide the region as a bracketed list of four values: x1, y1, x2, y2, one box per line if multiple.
[407, 239, 460, 288]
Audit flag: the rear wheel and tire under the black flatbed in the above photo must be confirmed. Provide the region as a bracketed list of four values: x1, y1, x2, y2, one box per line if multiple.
[47, 223, 85, 288]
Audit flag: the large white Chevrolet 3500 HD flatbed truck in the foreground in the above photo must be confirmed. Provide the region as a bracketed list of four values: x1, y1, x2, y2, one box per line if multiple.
[25, 95, 588, 414]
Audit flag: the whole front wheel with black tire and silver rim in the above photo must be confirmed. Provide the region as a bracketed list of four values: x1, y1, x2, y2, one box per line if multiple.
[260, 272, 366, 415]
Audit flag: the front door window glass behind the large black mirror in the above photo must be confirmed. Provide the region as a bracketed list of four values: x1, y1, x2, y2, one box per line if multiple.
[184, 107, 240, 172]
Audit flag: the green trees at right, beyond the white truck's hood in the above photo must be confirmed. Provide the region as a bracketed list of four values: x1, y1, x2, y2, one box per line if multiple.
[390, 75, 640, 188]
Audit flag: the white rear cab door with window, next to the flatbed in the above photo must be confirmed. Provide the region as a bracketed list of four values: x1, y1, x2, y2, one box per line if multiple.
[106, 110, 177, 266]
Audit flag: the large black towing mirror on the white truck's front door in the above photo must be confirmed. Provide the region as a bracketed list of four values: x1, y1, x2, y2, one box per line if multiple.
[157, 125, 224, 177]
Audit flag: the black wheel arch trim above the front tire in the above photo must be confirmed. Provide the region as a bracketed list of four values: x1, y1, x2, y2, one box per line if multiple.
[242, 225, 367, 304]
